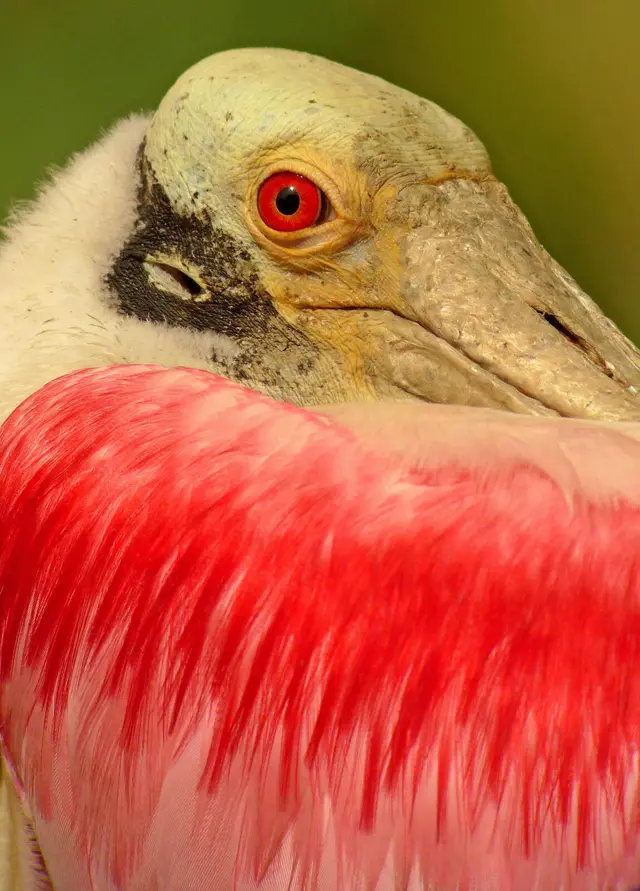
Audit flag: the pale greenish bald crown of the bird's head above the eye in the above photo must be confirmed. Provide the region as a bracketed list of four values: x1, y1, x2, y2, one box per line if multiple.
[147, 49, 491, 223]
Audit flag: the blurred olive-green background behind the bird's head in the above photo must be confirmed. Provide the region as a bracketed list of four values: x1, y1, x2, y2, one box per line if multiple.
[0, 0, 640, 342]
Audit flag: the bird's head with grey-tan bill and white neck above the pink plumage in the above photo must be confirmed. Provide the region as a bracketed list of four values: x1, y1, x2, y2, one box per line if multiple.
[5, 49, 640, 419]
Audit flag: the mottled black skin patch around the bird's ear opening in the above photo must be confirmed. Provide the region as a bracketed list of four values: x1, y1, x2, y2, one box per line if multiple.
[106, 144, 316, 387]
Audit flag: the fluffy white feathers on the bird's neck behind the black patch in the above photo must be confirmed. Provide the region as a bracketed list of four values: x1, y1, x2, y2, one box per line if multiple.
[0, 116, 235, 421]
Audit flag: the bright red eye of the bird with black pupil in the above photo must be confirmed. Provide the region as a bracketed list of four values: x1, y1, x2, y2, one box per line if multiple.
[258, 172, 323, 232]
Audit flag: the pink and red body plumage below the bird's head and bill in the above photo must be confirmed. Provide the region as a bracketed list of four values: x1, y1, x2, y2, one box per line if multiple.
[0, 366, 640, 891]
